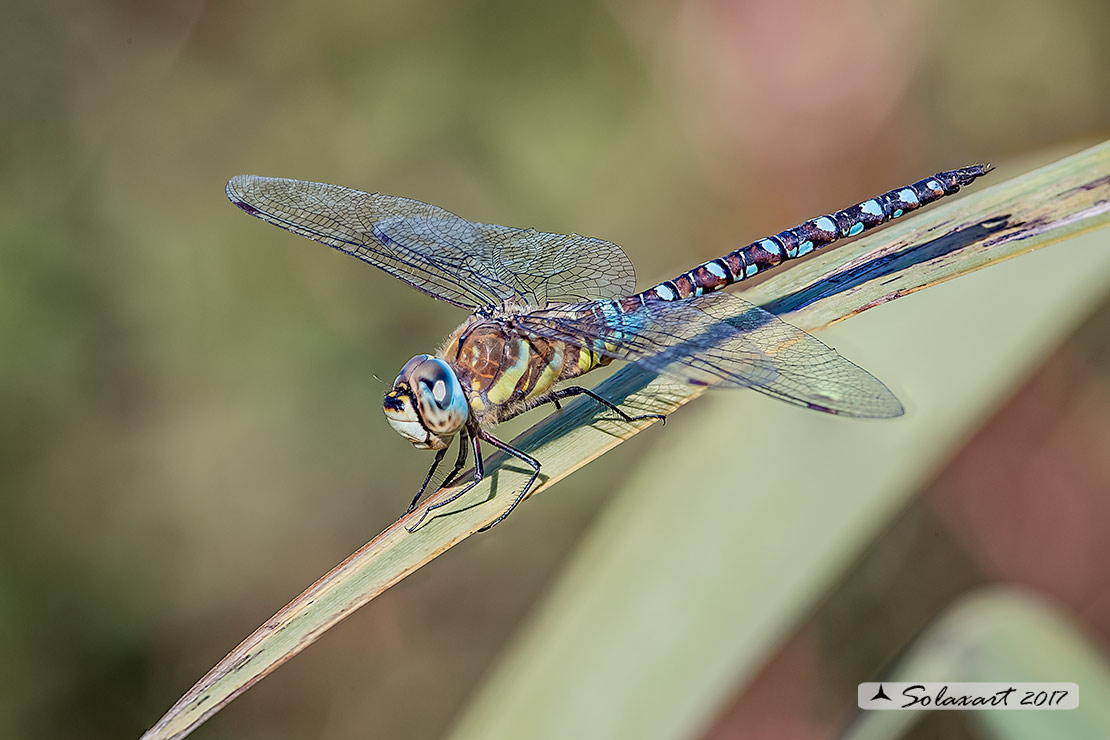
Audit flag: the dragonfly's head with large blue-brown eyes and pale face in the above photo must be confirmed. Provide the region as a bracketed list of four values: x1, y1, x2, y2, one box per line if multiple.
[383, 355, 468, 449]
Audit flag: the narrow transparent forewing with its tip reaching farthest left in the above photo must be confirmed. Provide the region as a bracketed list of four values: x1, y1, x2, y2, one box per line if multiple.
[226, 175, 514, 311]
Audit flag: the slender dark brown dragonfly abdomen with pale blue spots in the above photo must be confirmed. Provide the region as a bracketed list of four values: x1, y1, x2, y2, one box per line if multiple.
[634, 164, 990, 301]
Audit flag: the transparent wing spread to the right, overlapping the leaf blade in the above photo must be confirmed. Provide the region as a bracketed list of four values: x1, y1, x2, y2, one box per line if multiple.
[514, 293, 902, 417]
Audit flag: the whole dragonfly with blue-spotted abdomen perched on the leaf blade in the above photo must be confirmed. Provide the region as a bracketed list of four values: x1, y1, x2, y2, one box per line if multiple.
[226, 164, 991, 531]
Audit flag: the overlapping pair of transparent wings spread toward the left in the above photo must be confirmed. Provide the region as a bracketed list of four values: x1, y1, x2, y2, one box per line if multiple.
[226, 175, 636, 311]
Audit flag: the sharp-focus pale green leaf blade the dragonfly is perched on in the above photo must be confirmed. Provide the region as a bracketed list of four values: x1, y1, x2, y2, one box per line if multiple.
[143, 144, 1110, 740]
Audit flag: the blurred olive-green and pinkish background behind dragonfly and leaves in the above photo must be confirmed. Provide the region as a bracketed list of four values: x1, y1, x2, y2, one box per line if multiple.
[0, 0, 1110, 739]
